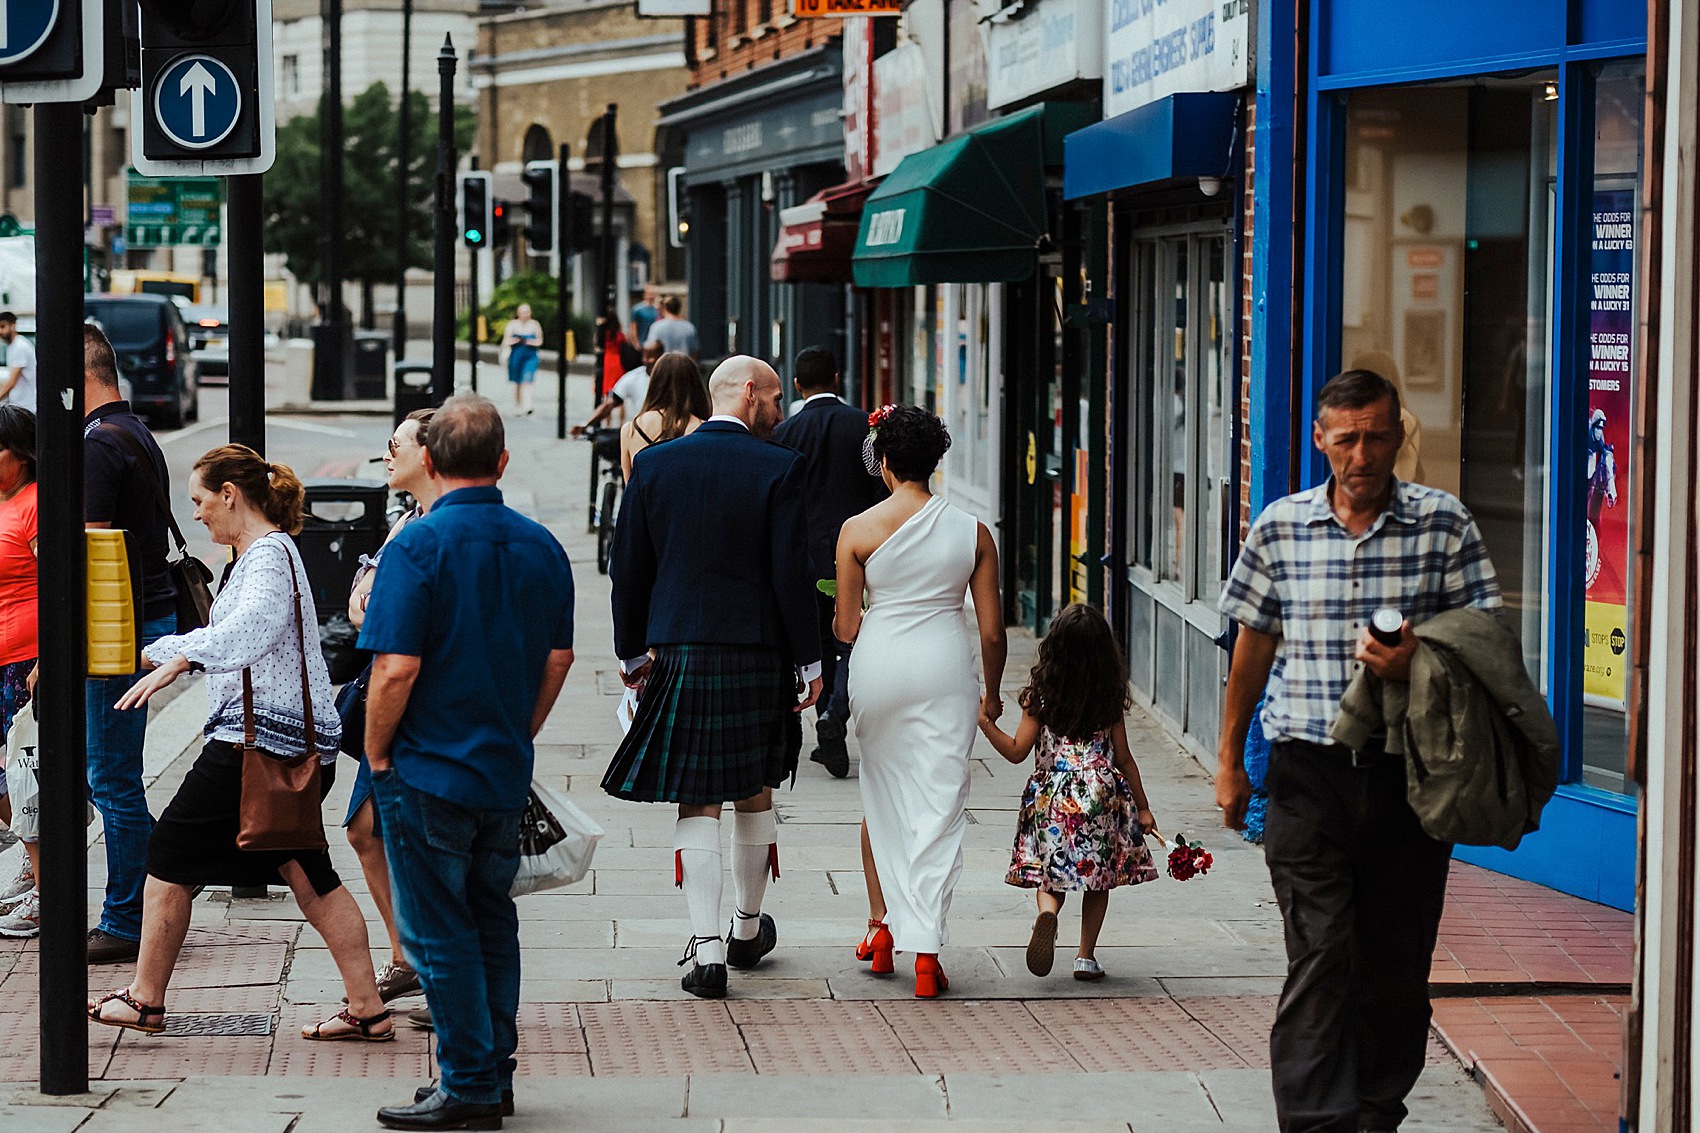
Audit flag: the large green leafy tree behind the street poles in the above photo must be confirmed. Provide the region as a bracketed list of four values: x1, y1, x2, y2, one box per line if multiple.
[265, 83, 476, 320]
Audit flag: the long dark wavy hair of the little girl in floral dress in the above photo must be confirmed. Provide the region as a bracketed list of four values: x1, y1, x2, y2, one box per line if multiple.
[1018, 602, 1134, 740]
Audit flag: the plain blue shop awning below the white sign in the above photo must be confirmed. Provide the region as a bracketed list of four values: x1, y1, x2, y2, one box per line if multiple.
[1063, 90, 1243, 201]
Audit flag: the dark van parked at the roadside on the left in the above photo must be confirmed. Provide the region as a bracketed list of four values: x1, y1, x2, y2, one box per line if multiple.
[83, 294, 201, 429]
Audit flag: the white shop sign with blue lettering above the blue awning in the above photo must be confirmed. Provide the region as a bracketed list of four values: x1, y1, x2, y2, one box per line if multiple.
[1103, 0, 1251, 117]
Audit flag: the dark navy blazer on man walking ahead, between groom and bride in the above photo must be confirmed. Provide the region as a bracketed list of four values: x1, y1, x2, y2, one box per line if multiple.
[774, 398, 886, 578]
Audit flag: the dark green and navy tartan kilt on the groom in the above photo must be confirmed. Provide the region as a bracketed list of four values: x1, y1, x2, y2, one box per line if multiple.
[602, 645, 802, 806]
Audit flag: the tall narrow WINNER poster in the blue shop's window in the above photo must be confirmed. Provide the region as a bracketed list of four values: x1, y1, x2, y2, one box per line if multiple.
[1583, 189, 1635, 708]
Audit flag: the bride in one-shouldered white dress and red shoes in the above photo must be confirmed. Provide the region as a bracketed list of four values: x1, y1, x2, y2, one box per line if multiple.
[835, 405, 1005, 999]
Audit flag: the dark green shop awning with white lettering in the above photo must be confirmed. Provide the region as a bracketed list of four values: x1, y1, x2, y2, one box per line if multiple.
[853, 104, 1085, 288]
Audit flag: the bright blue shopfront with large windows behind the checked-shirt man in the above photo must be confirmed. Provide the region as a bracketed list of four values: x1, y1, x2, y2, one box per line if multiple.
[1251, 0, 1646, 908]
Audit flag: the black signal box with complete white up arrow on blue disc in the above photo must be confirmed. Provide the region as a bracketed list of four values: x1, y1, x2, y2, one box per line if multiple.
[131, 0, 277, 175]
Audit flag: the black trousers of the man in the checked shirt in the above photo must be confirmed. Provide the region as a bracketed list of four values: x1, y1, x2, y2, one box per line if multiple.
[1263, 742, 1452, 1133]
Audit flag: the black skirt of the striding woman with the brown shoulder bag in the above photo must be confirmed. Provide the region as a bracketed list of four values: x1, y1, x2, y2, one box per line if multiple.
[148, 740, 342, 897]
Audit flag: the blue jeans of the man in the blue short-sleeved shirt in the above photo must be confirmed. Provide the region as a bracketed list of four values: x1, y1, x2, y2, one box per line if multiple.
[372, 769, 524, 1106]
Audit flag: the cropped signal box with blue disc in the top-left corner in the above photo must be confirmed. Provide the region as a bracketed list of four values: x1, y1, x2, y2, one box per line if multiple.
[0, 0, 105, 102]
